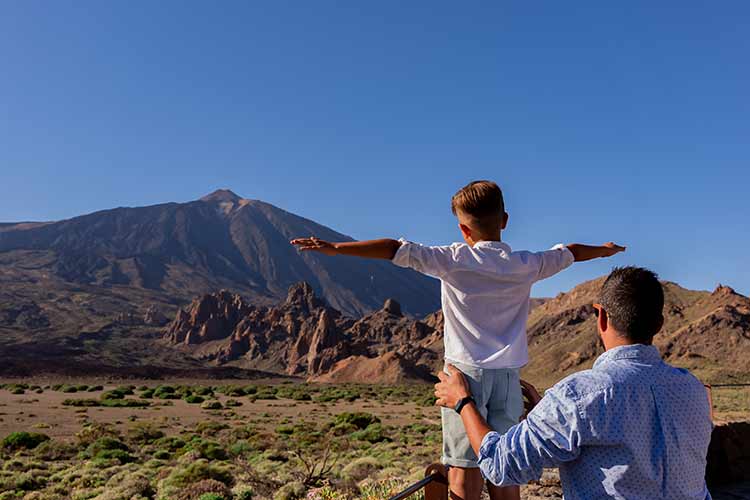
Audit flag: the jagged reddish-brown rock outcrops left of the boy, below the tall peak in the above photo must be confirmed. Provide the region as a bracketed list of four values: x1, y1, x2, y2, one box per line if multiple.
[164, 283, 439, 382]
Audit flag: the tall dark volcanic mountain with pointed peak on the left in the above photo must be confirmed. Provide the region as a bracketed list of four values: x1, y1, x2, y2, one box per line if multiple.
[0, 190, 439, 318]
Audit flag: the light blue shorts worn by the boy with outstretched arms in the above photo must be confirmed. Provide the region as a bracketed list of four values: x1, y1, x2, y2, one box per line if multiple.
[442, 362, 523, 468]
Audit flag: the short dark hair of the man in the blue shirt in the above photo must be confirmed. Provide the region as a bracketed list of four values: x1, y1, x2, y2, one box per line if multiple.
[599, 266, 664, 344]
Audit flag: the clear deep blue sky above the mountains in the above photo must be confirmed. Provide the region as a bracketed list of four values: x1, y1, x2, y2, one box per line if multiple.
[0, 0, 750, 295]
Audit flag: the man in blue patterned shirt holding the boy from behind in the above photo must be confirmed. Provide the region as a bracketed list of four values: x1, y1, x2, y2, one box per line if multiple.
[435, 267, 712, 500]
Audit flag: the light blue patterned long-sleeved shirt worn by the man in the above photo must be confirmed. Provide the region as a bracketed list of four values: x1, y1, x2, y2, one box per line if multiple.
[479, 344, 712, 500]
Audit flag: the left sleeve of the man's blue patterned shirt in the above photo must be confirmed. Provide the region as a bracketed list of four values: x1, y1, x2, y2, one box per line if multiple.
[479, 388, 582, 486]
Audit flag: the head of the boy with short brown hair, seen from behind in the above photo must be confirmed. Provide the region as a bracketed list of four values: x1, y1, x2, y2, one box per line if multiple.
[451, 181, 508, 245]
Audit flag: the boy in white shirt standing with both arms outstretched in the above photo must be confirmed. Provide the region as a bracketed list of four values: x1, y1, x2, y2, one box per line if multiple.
[291, 181, 625, 500]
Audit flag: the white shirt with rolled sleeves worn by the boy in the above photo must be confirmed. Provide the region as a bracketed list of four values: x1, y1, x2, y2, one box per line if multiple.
[393, 239, 574, 368]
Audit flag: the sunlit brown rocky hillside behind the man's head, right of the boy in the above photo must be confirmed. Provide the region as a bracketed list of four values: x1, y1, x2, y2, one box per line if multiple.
[524, 278, 750, 384]
